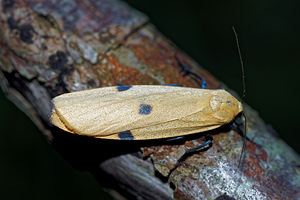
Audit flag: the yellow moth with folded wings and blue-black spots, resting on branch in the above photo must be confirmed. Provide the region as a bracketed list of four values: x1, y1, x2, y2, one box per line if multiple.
[51, 85, 243, 140]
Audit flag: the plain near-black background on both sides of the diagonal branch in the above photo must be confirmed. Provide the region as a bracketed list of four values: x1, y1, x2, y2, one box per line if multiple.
[0, 0, 300, 199]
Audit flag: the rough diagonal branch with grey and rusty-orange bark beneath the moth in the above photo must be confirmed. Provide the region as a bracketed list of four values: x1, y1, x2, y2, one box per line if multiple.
[0, 0, 300, 199]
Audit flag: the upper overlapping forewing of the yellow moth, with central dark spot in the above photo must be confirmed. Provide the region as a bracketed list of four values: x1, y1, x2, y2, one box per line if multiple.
[52, 86, 216, 137]
